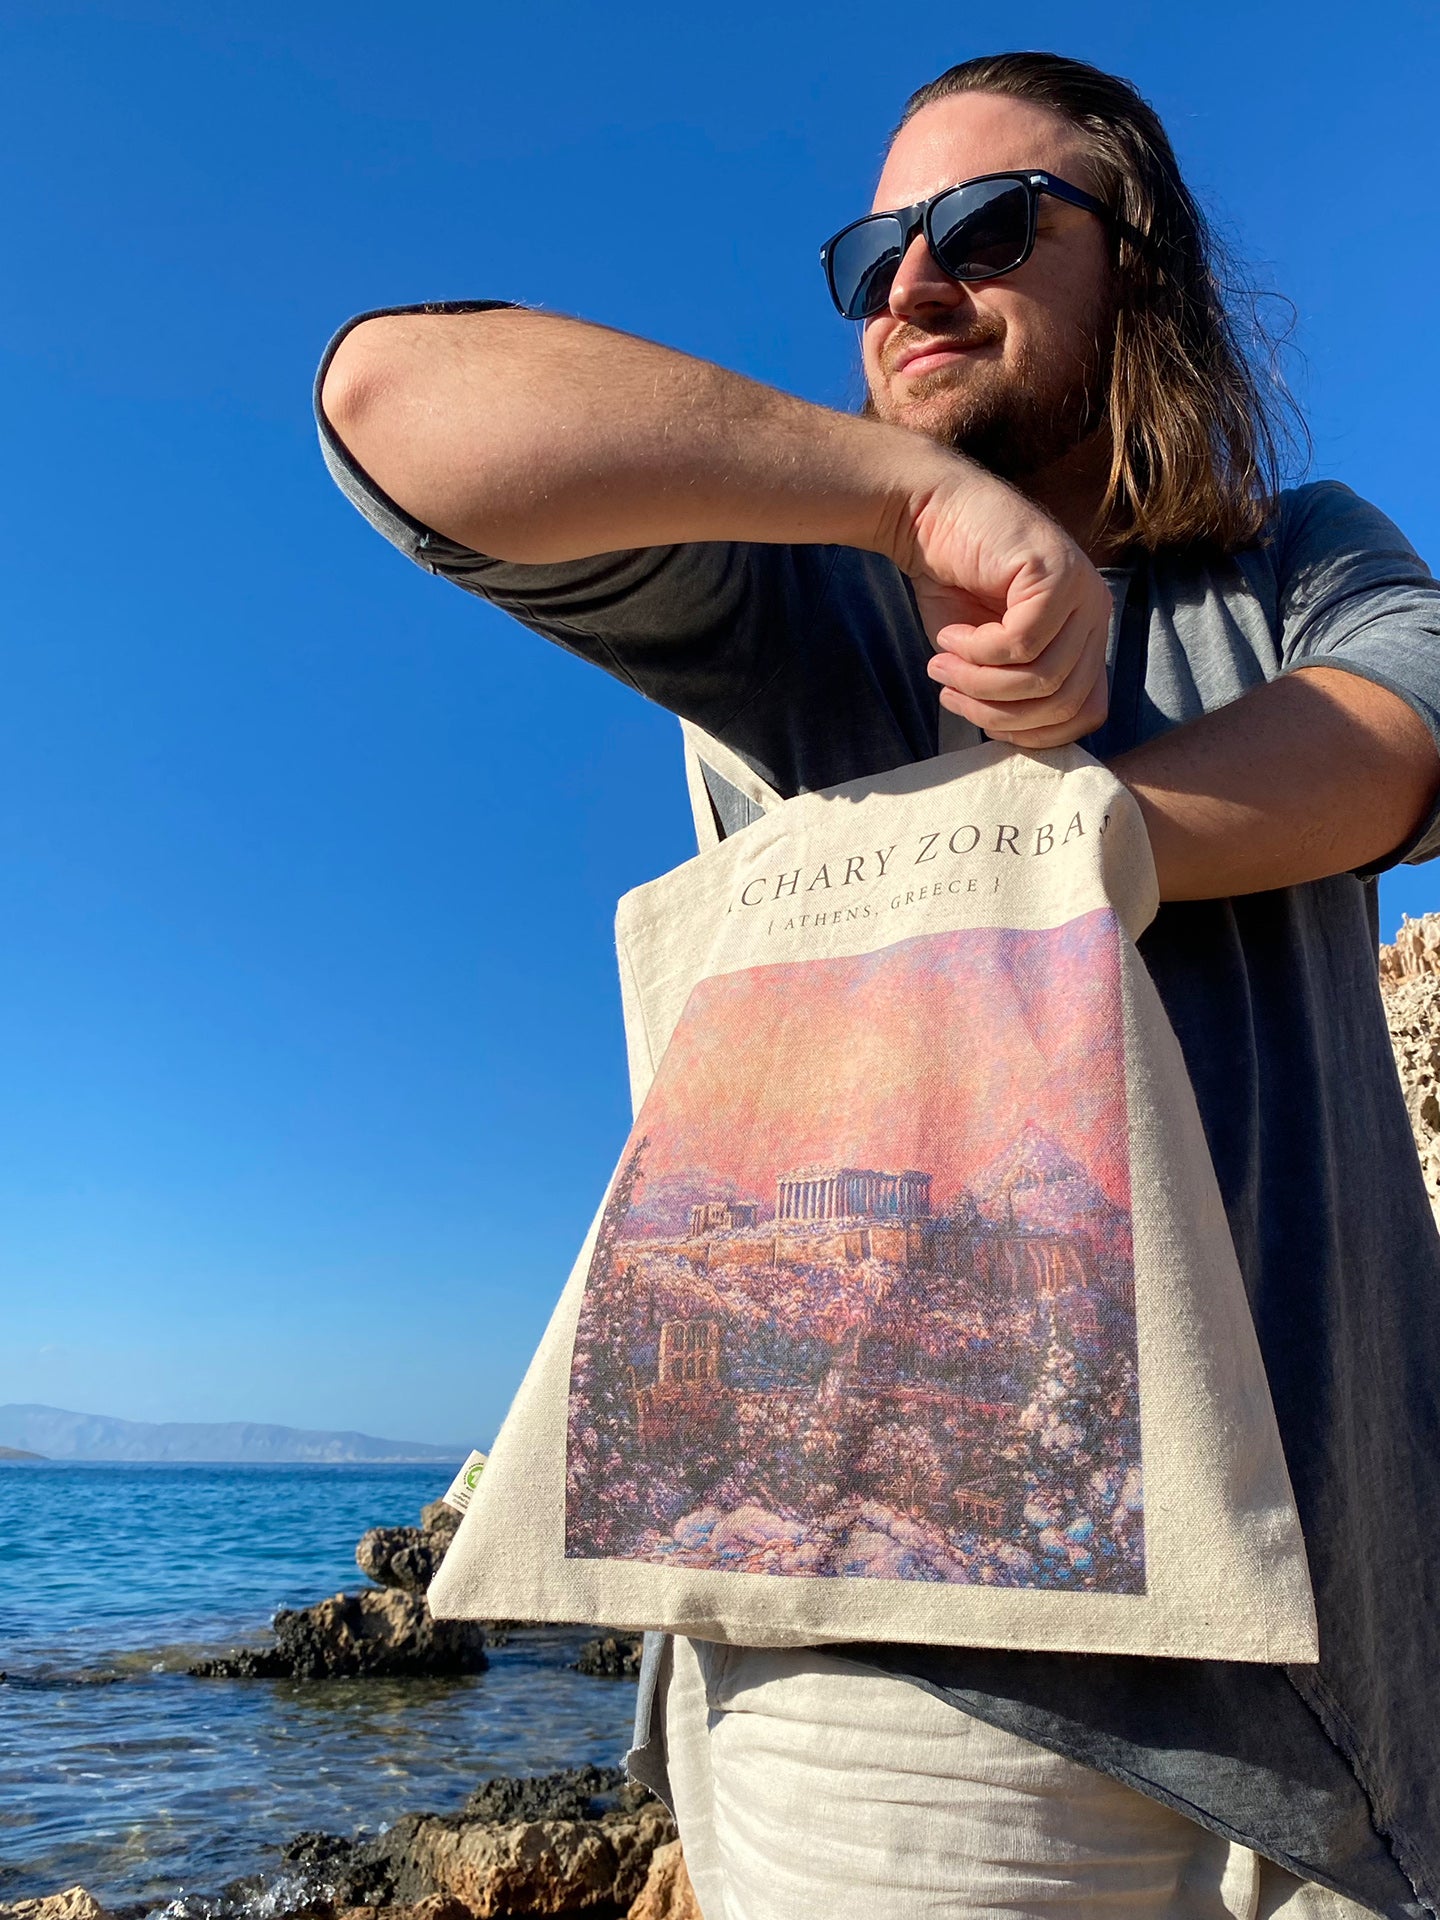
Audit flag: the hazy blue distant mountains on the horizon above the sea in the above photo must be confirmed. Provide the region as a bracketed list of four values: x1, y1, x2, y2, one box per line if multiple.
[0, 1405, 467, 1467]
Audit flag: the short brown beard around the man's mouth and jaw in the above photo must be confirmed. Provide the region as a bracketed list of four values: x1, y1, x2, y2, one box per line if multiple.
[862, 311, 1114, 490]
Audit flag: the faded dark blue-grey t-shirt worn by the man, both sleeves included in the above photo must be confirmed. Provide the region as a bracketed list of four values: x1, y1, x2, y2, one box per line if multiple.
[321, 307, 1440, 1916]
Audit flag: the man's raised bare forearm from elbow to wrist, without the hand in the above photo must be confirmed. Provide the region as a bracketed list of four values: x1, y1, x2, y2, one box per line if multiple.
[321, 309, 966, 563]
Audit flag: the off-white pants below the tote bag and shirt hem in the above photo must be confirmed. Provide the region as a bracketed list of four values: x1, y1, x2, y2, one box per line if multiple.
[657, 1638, 1369, 1920]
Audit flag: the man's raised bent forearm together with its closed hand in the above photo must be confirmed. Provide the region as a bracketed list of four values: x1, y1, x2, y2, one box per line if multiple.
[321, 309, 1136, 747]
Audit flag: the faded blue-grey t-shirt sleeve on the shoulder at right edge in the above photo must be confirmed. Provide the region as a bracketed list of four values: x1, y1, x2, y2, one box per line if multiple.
[1275, 480, 1440, 874]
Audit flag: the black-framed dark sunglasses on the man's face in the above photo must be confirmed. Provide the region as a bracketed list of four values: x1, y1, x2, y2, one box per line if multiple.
[820, 173, 1110, 321]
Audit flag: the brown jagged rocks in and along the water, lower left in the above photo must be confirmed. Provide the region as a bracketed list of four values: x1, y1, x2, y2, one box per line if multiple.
[0, 1501, 675, 1920]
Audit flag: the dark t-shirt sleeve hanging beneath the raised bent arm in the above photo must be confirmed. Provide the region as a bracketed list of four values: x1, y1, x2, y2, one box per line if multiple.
[315, 300, 835, 778]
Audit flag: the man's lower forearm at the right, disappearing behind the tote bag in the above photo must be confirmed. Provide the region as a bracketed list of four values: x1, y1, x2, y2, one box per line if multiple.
[1112, 666, 1440, 900]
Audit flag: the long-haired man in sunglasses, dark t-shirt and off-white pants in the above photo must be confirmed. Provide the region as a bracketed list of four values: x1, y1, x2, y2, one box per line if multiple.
[321, 54, 1440, 1920]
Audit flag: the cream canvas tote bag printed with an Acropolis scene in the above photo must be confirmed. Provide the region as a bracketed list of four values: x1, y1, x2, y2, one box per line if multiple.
[430, 732, 1317, 1661]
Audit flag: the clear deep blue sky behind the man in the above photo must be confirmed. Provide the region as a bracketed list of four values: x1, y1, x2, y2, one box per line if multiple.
[0, 0, 1440, 1444]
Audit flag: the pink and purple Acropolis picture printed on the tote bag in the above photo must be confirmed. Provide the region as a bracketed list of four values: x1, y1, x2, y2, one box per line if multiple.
[566, 912, 1144, 1594]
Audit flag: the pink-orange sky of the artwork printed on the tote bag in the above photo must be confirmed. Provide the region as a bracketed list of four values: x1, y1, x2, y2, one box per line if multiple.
[636, 910, 1131, 1213]
